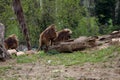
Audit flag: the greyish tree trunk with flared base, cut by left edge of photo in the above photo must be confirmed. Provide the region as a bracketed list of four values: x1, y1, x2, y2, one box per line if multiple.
[0, 23, 10, 61]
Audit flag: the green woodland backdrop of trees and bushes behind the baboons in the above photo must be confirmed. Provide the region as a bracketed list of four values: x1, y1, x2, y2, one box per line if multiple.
[0, 0, 120, 47]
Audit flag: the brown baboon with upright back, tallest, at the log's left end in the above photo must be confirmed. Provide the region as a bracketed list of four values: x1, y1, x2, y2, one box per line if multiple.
[38, 24, 57, 51]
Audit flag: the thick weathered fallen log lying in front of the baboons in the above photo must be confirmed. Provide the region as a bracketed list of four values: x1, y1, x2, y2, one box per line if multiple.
[48, 36, 96, 52]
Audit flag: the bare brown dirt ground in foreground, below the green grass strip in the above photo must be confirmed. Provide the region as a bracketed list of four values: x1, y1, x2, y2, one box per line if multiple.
[0, 46, 120, 80]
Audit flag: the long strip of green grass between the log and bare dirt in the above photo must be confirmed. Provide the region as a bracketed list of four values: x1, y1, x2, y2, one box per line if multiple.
[13, 46, 120, 66]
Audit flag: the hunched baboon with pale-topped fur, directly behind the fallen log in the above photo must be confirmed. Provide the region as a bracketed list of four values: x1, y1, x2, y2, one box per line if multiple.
[54, 28, 72, 44]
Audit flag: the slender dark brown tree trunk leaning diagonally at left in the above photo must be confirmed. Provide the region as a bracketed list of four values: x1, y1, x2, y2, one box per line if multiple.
[13, 0, 31, 50]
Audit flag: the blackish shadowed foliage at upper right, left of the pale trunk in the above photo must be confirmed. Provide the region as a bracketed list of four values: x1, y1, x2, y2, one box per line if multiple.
[95, 0, 115, 25]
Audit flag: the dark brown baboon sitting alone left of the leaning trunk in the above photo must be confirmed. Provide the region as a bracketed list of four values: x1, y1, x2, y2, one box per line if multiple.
[4, 34, 19, 50]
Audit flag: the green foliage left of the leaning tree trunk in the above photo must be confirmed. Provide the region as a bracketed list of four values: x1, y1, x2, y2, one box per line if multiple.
[0, 0, 23, 41]
